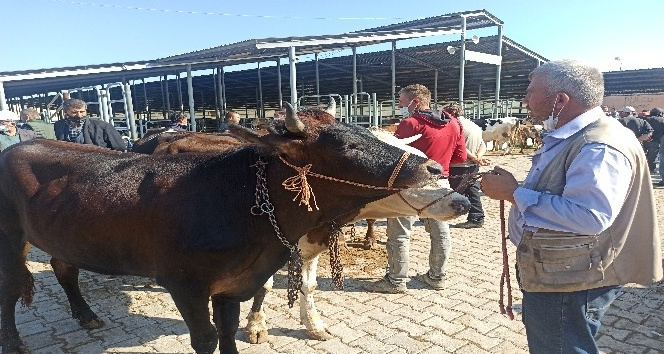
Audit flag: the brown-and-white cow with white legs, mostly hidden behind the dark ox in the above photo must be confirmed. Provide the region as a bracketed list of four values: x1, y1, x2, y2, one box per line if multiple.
[134, 129, 469, 343]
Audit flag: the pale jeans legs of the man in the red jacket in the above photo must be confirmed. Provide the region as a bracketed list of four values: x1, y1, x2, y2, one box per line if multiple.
[386, 216, 452, 285]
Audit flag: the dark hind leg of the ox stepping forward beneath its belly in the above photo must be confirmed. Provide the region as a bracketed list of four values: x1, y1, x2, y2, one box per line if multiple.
[51, 257, 104, 329]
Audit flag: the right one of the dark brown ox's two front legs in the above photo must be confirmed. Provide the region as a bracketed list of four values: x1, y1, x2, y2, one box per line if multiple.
[212, 295, 240, 354]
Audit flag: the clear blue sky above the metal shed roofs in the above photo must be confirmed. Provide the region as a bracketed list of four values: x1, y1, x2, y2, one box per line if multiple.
[0, 0, 664, 71]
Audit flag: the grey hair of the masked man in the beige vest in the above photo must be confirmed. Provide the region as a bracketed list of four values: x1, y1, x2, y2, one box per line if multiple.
[529, 59, 604, 108]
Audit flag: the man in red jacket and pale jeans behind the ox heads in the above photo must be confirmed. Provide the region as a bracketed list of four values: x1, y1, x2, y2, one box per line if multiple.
[364, 84, 466, 293]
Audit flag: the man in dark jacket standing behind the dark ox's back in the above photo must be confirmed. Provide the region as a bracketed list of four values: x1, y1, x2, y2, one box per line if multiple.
[54, 98, 127, 151]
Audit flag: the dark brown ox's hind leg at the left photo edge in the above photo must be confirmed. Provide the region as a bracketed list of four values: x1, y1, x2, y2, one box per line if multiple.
[0, 235, 34, 354]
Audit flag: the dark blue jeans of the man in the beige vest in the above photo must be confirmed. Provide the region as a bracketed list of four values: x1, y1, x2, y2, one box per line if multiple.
[522, 286, 622, 354]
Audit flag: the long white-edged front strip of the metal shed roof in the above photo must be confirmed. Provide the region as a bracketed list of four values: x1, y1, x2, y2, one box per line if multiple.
[0, 10, 502, 104]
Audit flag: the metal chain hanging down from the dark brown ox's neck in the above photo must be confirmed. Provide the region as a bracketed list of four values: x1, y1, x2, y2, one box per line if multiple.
[251, 158, 302, 308]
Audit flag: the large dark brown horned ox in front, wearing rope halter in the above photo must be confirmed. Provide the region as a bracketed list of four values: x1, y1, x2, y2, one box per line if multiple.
[0, 106, 440, 353]
